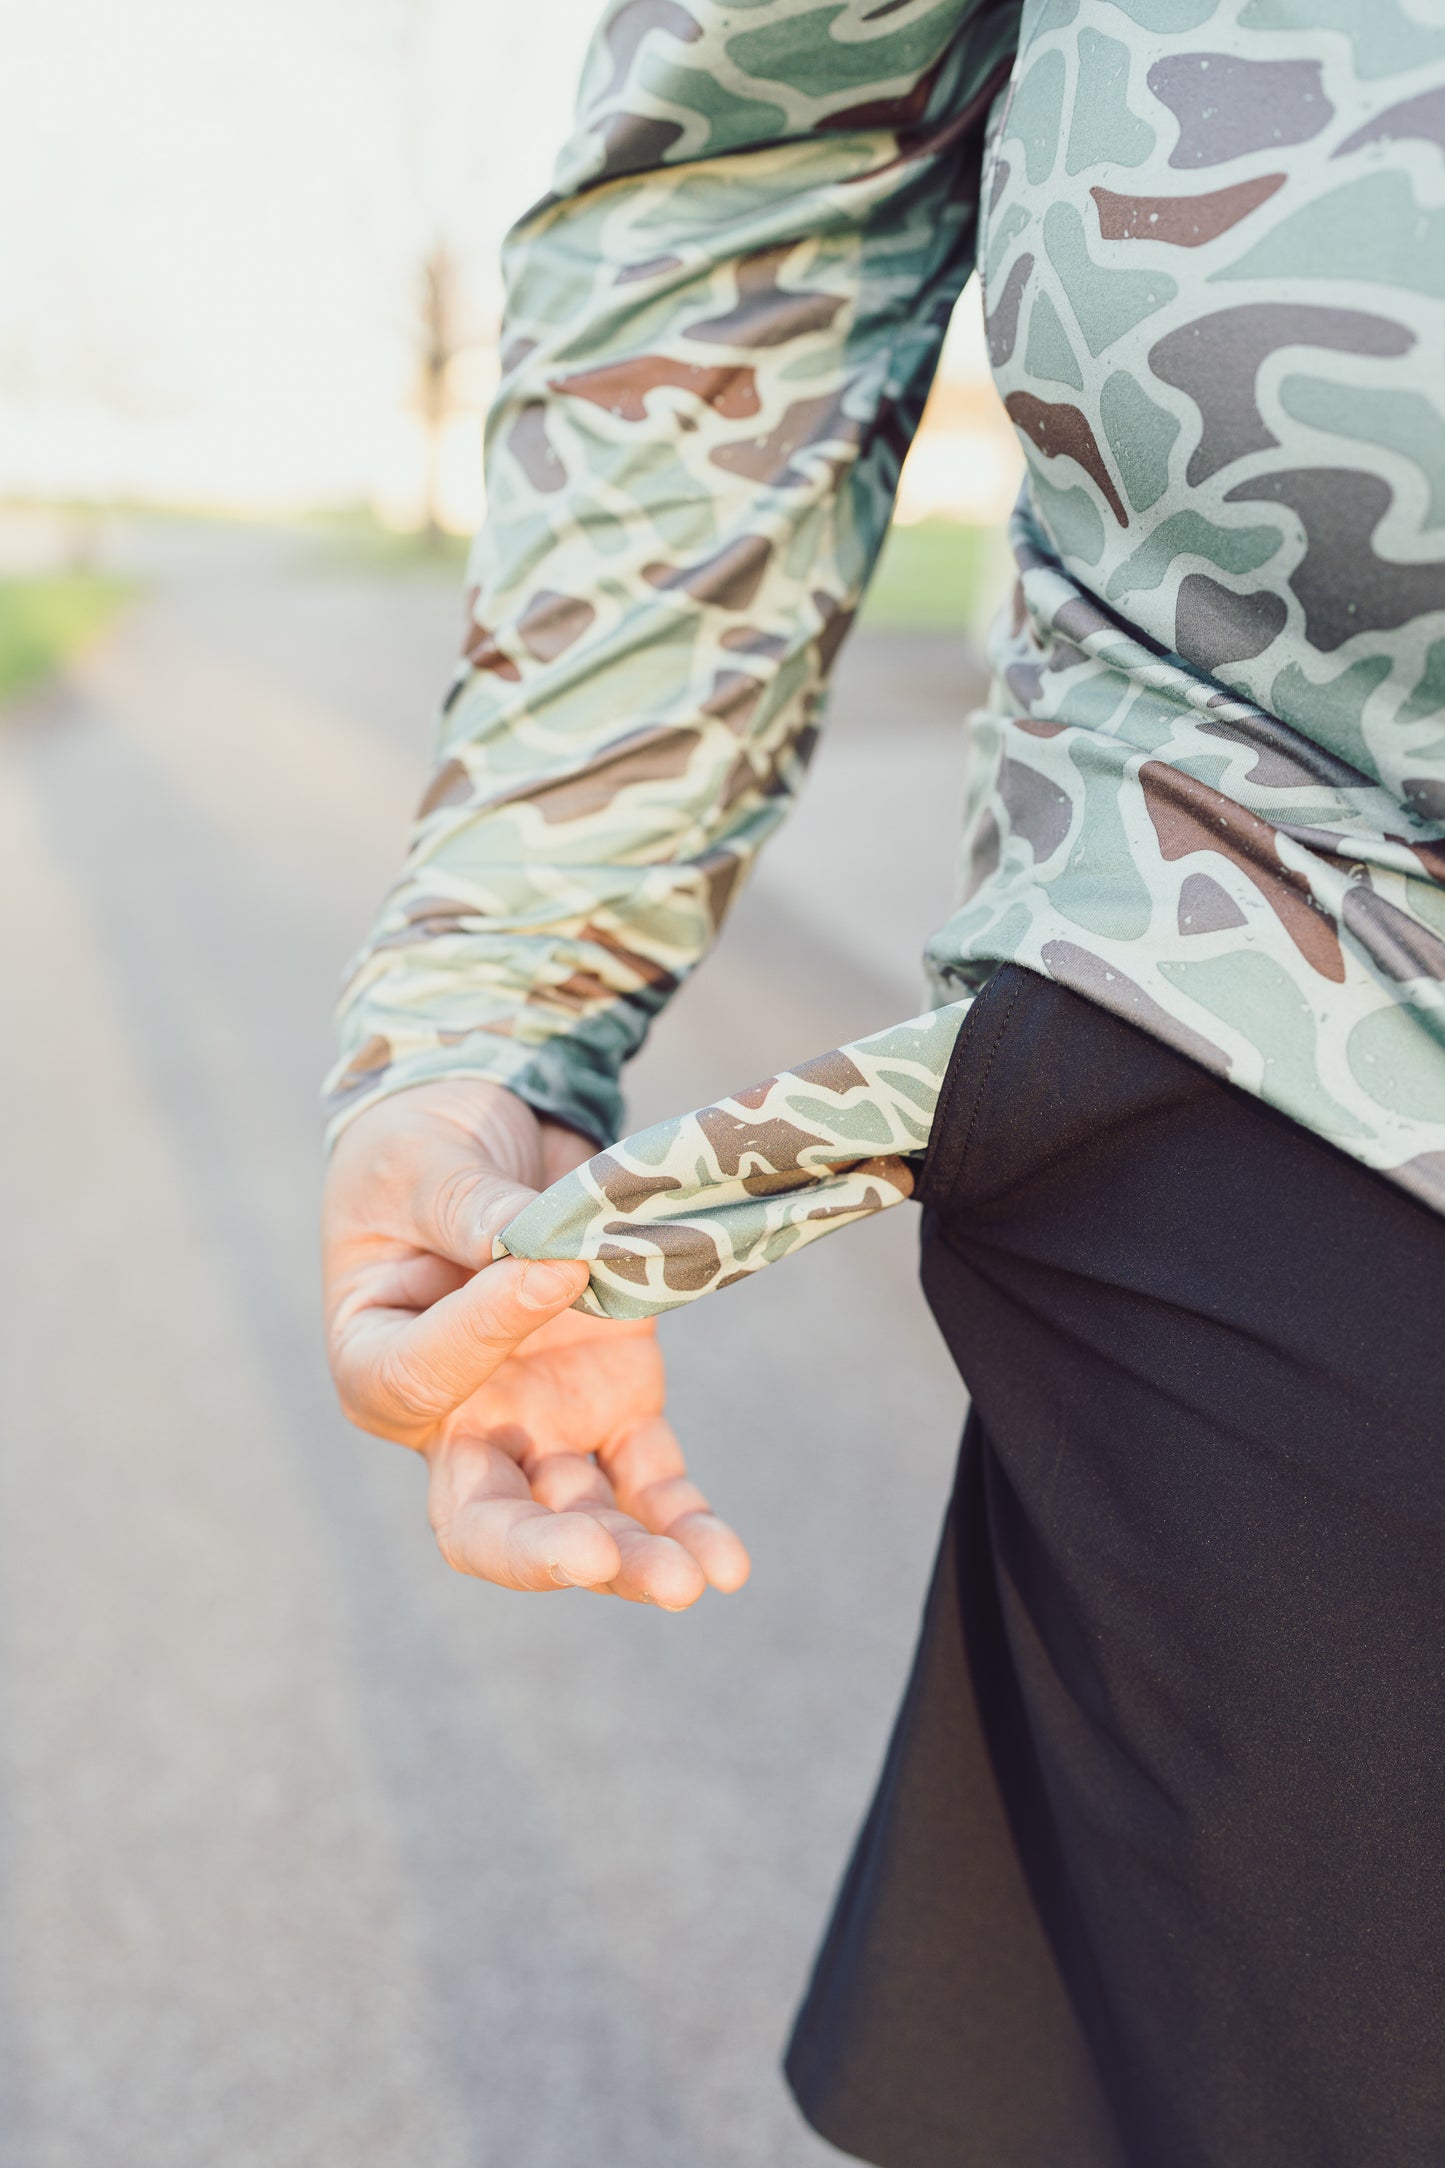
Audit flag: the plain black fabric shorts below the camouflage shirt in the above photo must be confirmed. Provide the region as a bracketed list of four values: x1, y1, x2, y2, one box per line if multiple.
[786, 967, 1445, 2168]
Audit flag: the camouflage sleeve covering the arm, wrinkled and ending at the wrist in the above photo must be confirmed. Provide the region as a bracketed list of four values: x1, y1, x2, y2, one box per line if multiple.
[327, 0, 1018, 1143]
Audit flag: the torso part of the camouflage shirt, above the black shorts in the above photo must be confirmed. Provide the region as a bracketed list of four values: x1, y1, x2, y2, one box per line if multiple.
[929, 0, 1445, 1208]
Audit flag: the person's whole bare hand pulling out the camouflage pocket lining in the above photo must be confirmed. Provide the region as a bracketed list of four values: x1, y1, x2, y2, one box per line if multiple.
[323, 1077, 747, 1611]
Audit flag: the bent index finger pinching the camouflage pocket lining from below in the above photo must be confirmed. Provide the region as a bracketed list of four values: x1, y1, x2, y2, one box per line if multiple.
[334, 1257, 587, 1444]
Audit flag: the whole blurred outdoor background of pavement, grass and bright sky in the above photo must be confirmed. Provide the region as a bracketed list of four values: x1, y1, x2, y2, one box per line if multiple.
[0, 0, 1016, 2168]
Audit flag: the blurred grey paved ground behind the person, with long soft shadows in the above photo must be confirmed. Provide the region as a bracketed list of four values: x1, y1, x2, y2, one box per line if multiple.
[0, 529, 987, 2168]
